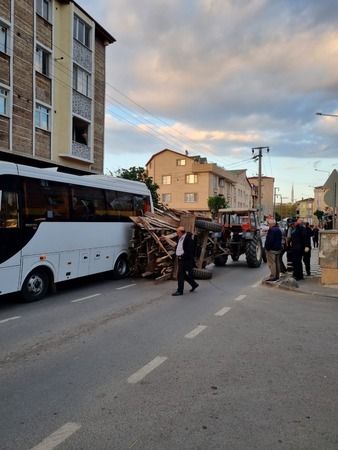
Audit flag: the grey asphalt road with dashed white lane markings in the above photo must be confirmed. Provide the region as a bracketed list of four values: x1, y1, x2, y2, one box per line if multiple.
[0, 261, 338, 450]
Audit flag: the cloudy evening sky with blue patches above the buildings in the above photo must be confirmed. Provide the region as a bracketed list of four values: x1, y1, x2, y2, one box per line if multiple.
[78, 0, 338, 201]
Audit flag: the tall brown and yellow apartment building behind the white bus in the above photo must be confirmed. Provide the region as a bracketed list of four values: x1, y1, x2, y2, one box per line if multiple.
[0, 0, 115, 173]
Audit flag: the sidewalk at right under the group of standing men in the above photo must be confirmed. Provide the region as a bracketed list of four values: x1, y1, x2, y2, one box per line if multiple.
[262, 248, 338, 299]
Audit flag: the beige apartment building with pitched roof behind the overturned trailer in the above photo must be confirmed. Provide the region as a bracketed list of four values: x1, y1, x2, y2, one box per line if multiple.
[146, 149, 250, 211]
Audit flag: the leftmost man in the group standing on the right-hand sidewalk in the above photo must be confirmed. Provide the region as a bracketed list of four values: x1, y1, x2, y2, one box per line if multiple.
[264, 219, 282, 281]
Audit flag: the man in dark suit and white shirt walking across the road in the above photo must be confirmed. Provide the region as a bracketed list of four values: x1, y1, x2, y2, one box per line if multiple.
[172, 226, 199, 296]
